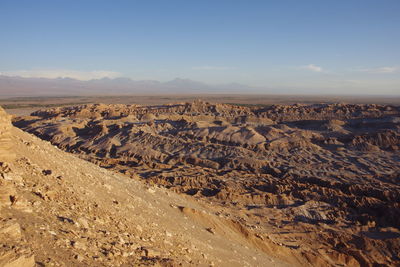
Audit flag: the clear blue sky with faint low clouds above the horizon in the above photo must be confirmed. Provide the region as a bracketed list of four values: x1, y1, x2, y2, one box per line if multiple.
[0, 0, 400, 95]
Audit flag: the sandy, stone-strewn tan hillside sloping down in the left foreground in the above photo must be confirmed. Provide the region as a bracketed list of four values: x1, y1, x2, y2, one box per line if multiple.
[0, 106, 294, 266]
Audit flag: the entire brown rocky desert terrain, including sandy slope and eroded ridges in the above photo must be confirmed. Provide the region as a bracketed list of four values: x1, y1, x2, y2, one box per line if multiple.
[0, 100, 400, 266]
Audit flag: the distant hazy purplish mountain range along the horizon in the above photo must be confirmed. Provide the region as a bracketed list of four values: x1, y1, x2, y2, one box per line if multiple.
[0, 75, 260, 97]
